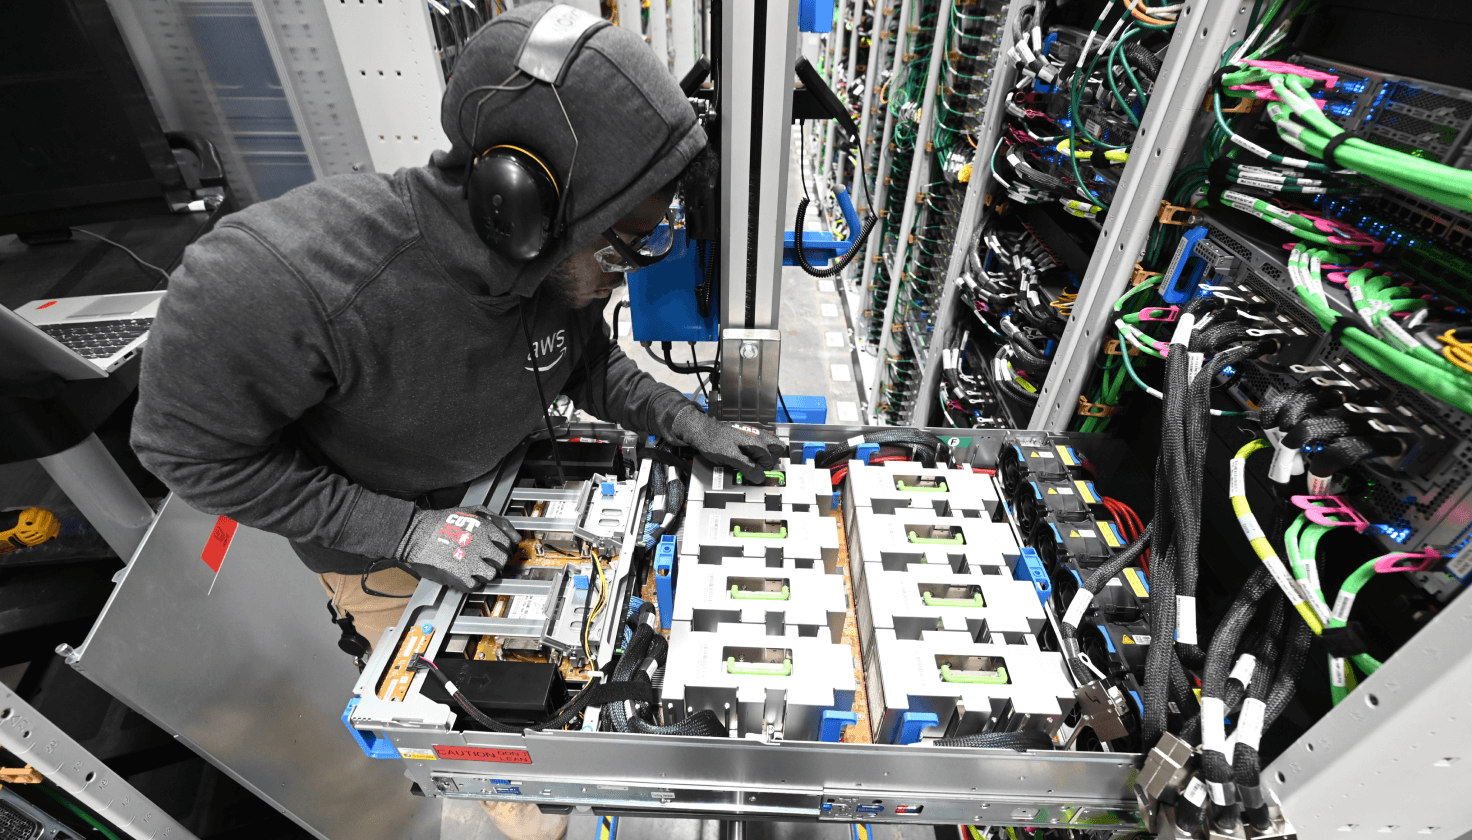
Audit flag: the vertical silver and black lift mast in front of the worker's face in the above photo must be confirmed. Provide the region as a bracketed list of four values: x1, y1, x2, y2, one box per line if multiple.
[715, 0, 798, 422]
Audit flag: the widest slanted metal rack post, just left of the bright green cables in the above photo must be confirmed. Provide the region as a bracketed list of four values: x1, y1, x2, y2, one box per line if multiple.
[1027, 1, 1250, 431]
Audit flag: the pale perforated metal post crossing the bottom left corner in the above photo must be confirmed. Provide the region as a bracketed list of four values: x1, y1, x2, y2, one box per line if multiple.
[0, 684, 196, 840]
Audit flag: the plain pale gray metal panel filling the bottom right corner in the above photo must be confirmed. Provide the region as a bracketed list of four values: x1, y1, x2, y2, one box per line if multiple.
[1263, 576, 1472, 840]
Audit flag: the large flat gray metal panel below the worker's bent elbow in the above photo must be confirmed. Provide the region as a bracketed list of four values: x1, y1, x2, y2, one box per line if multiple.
[68, 497, 434, 840]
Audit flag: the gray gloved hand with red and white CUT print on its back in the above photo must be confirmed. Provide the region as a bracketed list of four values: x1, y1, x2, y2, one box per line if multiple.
[394, 505, 521, 591]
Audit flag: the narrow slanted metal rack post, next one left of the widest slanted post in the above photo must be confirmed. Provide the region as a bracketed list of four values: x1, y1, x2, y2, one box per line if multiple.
[910, 0, 1030, 425]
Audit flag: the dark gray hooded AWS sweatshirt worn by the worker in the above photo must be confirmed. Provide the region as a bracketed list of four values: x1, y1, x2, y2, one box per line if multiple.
[132, 3, 705, 574]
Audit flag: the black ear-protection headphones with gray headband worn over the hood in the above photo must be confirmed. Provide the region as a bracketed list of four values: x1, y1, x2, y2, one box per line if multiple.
[461, 3, 611, 262]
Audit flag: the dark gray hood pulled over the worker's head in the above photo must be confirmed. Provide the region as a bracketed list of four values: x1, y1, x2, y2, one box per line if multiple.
[430, 3, 705, 297]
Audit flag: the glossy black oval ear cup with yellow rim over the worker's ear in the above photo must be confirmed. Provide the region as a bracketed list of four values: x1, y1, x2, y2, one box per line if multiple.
[465, 147, 558, 262]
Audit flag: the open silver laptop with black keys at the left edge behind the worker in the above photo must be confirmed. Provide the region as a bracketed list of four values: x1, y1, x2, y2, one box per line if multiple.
[0, 291, 165, 380]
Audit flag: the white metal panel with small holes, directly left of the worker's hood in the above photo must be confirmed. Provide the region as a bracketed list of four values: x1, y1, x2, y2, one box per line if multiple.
[325, 0, 449, 172]
